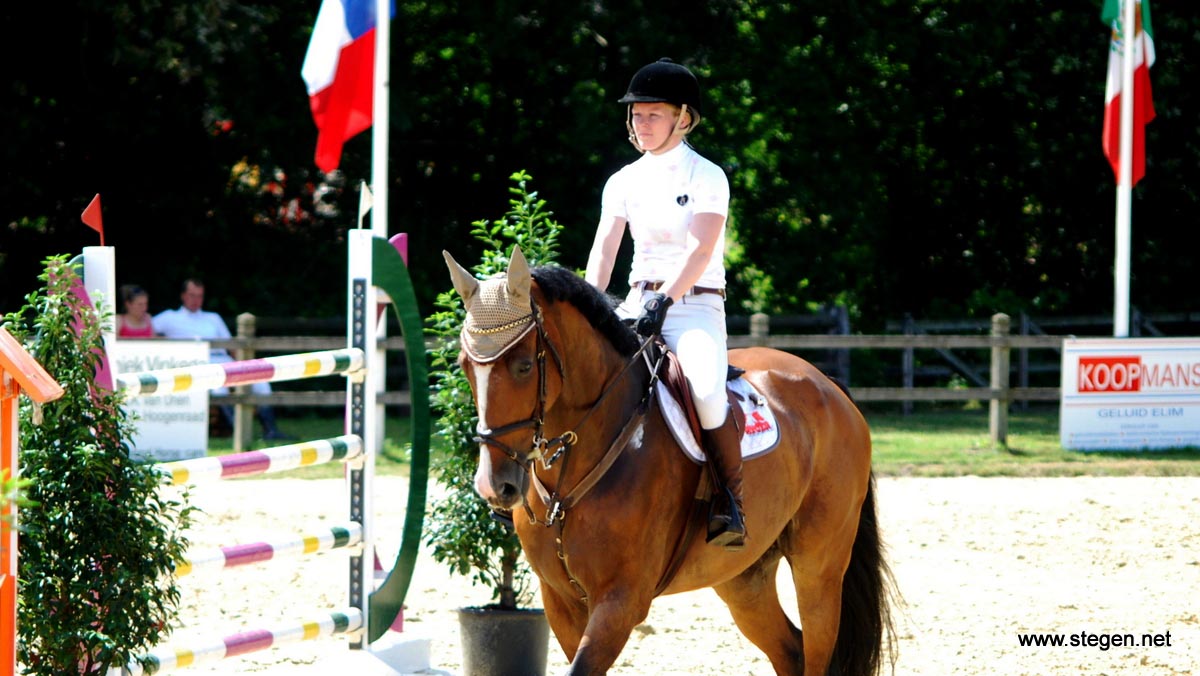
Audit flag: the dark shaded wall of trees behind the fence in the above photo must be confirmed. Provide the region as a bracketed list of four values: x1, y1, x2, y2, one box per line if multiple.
[0, 0, 1200, 333]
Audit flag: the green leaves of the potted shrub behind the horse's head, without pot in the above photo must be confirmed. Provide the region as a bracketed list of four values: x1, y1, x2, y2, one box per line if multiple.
[426, 172, 562, 609]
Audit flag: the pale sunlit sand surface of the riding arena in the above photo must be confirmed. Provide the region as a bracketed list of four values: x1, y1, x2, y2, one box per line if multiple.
[162, 477, 1200, 676]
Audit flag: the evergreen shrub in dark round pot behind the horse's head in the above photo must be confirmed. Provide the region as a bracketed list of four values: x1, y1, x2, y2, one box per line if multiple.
[426, 172, 562, 676]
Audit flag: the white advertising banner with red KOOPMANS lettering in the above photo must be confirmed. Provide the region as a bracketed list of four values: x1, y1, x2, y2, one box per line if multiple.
[1058, 337, 1200, 450]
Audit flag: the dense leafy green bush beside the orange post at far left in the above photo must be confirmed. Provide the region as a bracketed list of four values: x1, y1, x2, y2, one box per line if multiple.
[5, 257, 192, 676]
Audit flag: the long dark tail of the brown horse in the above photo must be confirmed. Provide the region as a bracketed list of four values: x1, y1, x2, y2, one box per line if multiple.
[829, 473, 895, 676]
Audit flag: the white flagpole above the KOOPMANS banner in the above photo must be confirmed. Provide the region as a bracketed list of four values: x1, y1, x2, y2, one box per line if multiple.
[1112, 0, 1139, 337]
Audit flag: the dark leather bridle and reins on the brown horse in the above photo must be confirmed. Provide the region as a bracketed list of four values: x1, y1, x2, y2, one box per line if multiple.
[472, 300, 664, 526]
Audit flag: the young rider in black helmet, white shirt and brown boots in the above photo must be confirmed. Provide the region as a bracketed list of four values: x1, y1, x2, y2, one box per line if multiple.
[587, 59, 745, 549]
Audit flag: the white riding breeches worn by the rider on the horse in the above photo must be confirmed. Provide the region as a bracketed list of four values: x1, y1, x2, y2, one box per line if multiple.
[617, 289, 730, 430]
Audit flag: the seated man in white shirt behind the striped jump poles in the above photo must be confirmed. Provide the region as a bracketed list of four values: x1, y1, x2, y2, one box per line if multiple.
[151, 279, 294, 441]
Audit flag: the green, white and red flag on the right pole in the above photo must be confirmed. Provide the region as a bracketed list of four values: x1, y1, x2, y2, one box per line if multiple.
[1100, 0, 1154, 185]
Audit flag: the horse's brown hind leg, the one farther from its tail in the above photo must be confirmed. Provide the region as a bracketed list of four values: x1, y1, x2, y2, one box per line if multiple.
[713, 549, 804, 676]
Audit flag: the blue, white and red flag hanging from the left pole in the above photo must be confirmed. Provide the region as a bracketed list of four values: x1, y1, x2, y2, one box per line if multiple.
[301, 0, 396, 172]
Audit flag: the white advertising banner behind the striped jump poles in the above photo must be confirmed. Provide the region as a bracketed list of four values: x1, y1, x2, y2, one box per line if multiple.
[109, 339, 209, 462]
